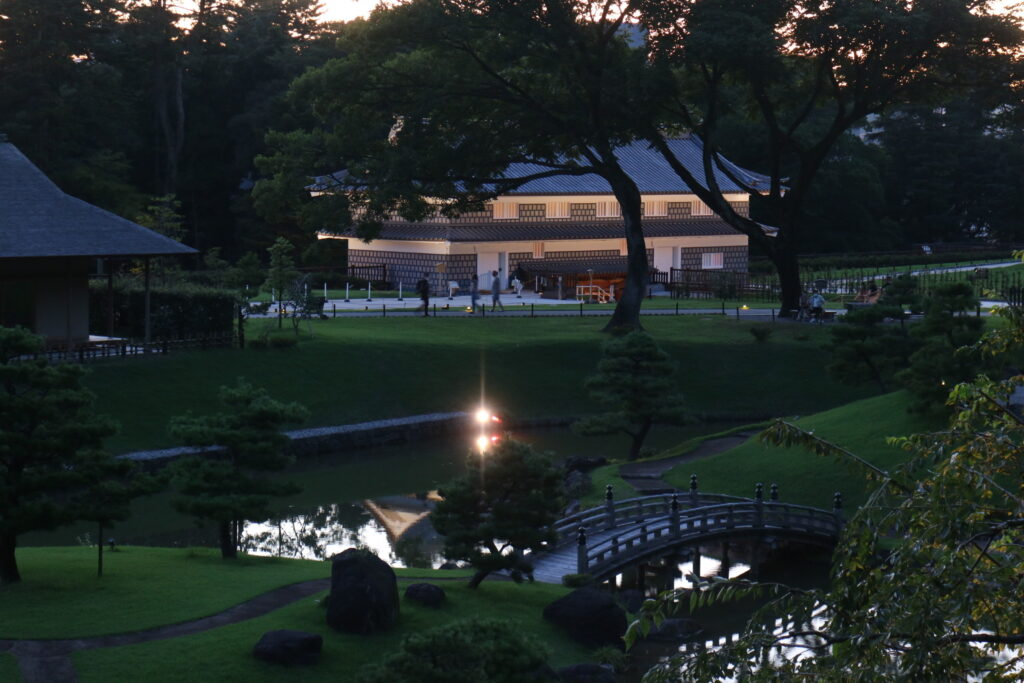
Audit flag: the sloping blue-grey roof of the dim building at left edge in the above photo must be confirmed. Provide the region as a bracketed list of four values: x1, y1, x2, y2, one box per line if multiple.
[0, 142, 196, 259]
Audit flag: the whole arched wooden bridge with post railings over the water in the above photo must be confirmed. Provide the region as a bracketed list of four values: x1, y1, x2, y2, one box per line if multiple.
[531, 476, 843, 584]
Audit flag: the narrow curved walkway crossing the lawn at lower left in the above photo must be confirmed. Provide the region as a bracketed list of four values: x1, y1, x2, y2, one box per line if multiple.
[0, 577, 465, 683]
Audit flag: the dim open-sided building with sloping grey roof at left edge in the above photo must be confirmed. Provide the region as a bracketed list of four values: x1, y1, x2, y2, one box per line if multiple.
[0, 135, 196, 347]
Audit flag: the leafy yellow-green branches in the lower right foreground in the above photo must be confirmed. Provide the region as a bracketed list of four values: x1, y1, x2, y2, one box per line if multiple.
[634, 307, 1024, 681]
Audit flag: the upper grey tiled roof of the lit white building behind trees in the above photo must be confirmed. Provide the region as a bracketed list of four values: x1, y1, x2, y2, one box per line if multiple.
[308, 135, 769, 196]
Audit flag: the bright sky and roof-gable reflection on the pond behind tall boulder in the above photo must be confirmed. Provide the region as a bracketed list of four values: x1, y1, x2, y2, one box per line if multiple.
[242, 492, 444, 568]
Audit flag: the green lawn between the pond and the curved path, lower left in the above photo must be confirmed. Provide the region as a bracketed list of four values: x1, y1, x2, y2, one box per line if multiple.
[0, 546, 469, 643]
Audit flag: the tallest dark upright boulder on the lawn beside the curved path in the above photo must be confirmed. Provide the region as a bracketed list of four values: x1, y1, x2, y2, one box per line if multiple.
[327, 548, 398, 634]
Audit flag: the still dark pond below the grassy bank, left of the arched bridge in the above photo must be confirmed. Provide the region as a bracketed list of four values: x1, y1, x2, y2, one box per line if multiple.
[19, 423, 729, 567]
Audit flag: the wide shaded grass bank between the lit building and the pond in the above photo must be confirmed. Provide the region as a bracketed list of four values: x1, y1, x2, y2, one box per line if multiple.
[87, 315, 870, 453]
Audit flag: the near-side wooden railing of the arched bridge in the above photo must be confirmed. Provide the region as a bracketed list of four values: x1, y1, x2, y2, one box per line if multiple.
[577, 495, 843, 573]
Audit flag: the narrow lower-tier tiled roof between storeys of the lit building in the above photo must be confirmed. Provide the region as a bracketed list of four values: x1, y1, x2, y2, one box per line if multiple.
[323, 217, 739, 242]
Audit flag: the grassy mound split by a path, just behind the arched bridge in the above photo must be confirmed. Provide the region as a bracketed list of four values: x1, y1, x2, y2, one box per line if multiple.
[665, 391, 941, 510]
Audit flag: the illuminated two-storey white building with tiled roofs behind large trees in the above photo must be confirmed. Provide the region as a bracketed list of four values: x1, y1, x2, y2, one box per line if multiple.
[311, 136, 768, 295]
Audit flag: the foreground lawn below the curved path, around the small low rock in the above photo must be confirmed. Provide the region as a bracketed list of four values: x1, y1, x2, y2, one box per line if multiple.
[74, 572, 590, 683]
